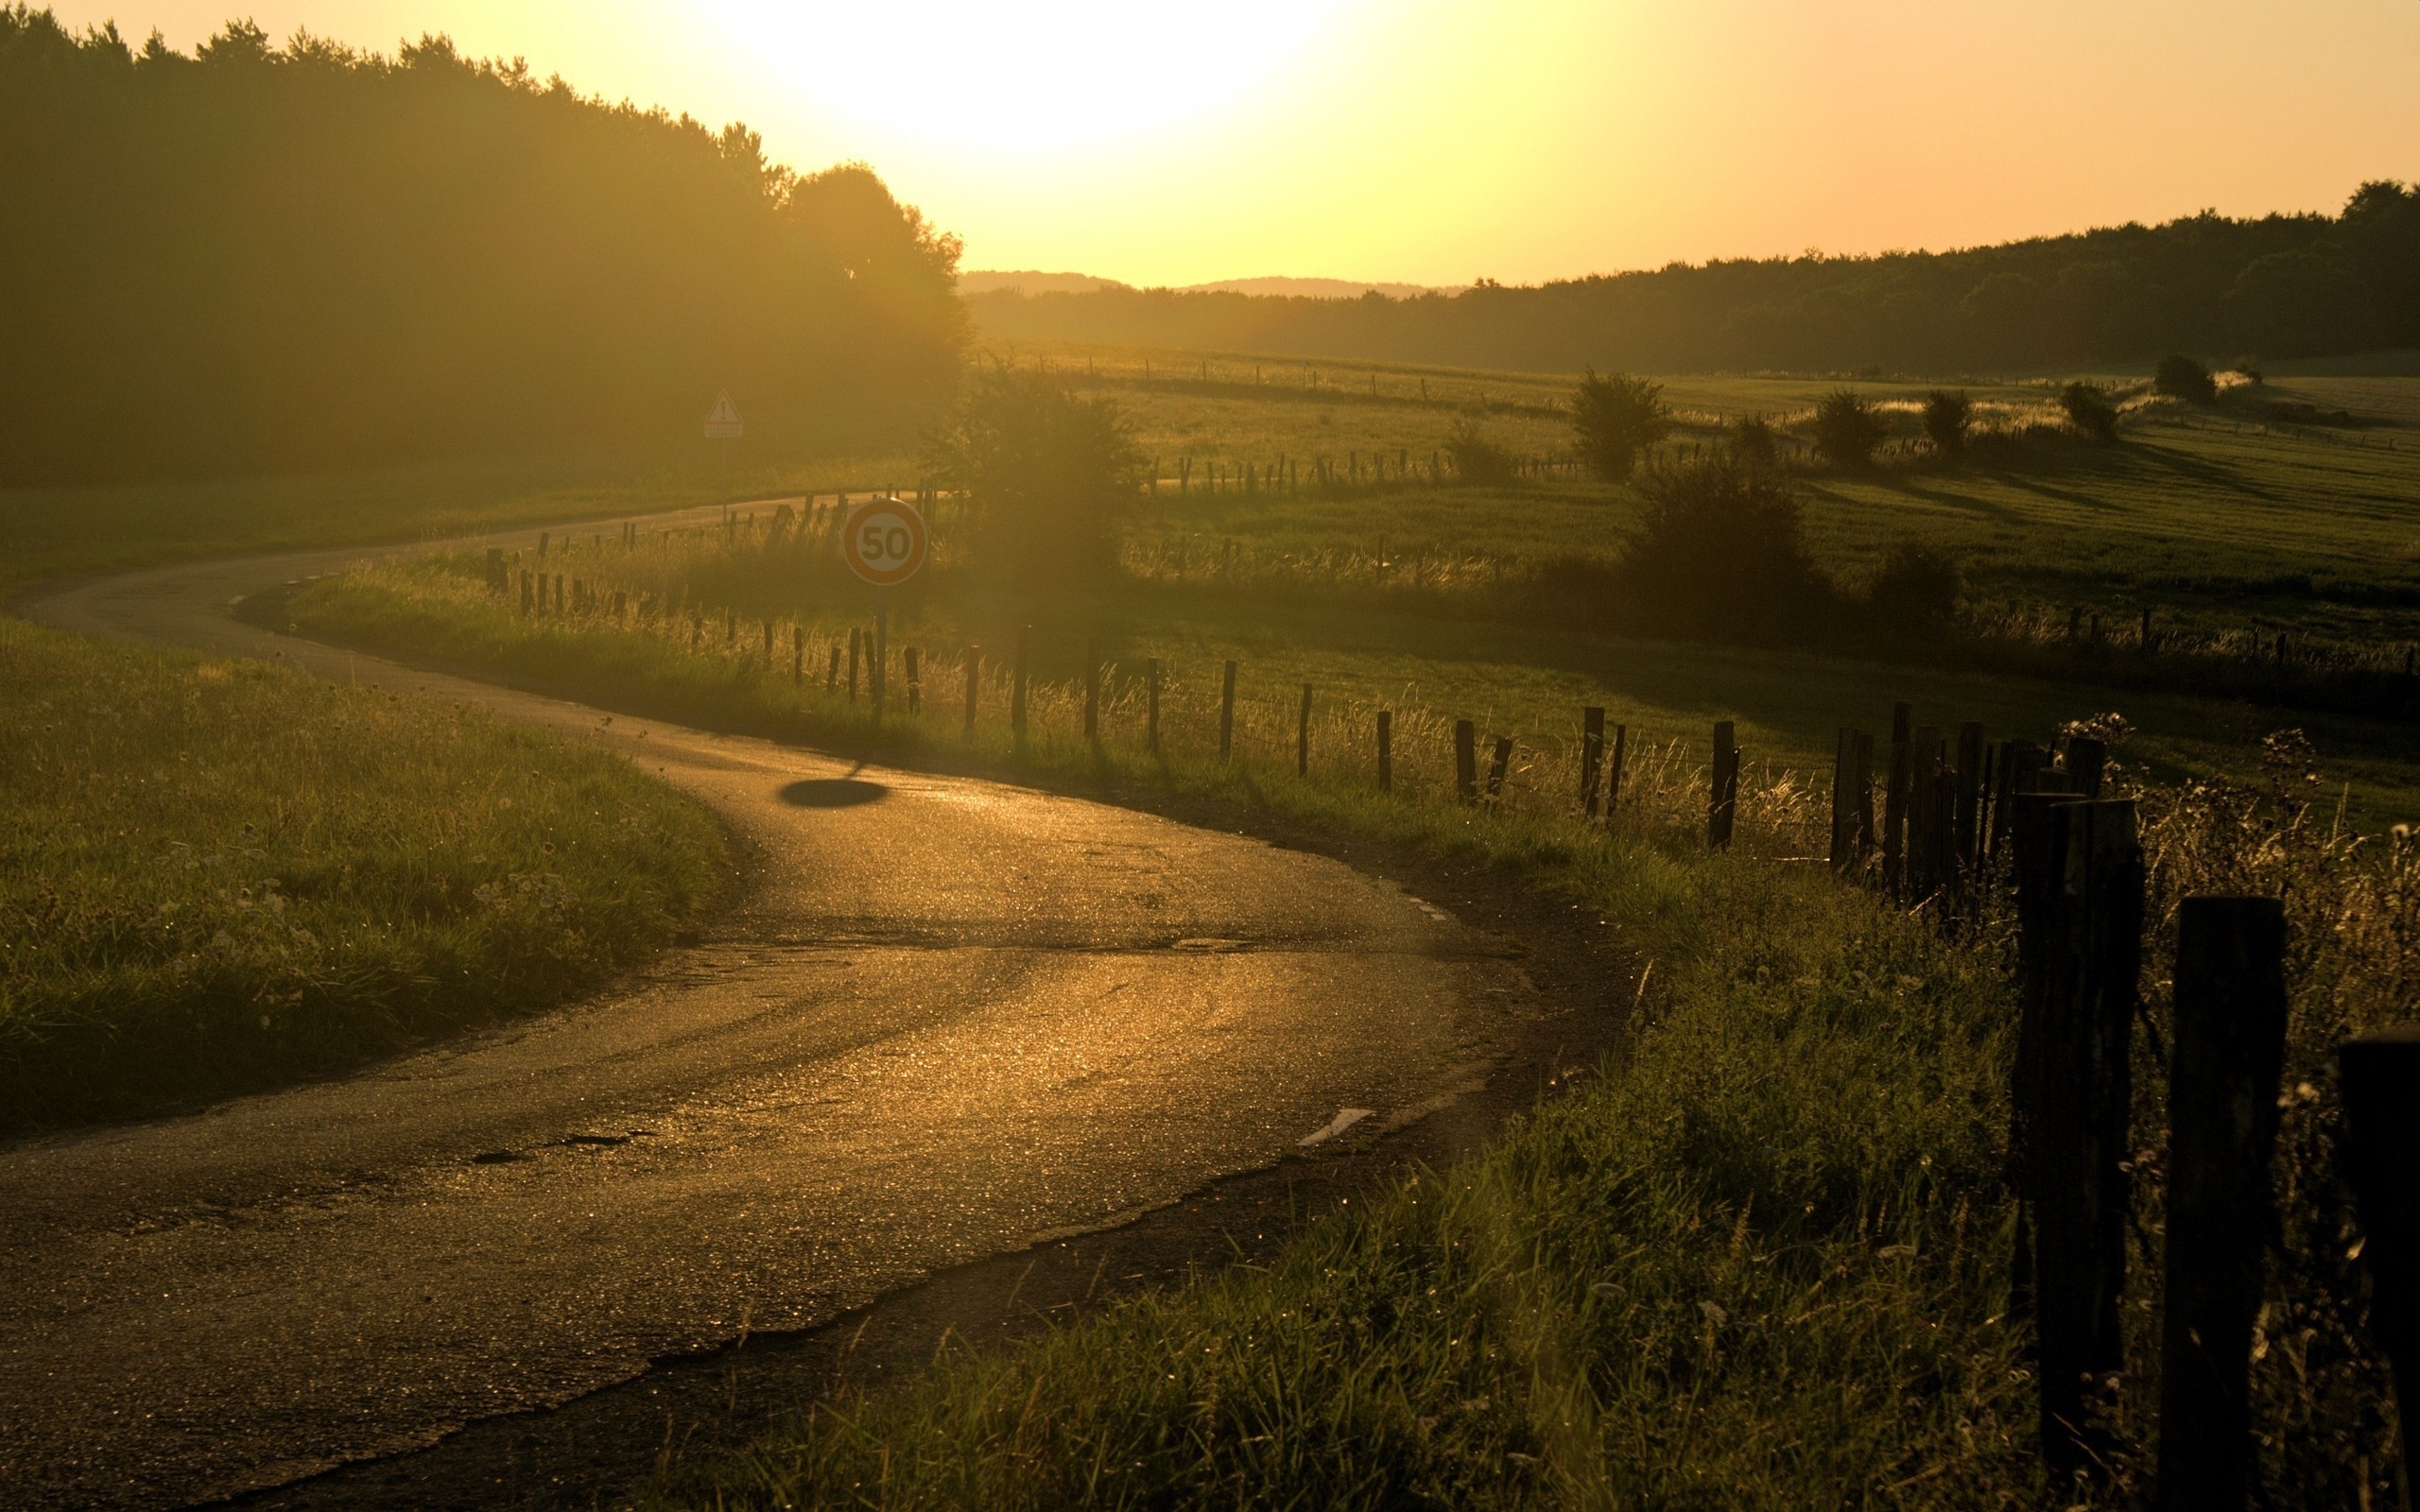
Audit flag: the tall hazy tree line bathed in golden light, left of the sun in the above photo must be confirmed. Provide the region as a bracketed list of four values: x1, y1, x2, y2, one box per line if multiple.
[0, 5, 965, 484]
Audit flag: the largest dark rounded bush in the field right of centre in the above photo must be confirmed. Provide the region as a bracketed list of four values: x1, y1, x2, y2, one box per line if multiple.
[1619, 462, 1834, 641]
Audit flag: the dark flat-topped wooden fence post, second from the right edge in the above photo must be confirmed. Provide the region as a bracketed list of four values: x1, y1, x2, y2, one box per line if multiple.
[2147, 895, 2285, 1512]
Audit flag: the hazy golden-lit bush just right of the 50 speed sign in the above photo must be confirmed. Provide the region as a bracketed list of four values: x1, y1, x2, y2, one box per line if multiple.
[925, 368, 1142, 586]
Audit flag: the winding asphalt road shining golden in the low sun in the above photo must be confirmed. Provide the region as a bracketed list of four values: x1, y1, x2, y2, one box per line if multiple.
[0, 512, 1530, 1507]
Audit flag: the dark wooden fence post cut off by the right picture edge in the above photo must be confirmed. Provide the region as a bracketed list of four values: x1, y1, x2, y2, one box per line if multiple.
[2335, 1025, 2420, 1476]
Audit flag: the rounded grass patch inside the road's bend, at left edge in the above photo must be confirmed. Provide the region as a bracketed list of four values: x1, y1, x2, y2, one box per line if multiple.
[0, 619, 723, 1132]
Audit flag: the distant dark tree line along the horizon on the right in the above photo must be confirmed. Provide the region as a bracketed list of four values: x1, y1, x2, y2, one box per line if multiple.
[968, 181, 2420, 372]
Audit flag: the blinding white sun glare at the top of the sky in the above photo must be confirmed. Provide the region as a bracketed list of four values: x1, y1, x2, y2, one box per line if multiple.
[714, 0, 1365, 155]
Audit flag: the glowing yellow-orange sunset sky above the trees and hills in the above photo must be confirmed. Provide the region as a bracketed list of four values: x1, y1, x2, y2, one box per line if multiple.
[48, 0, 2420, 285]
